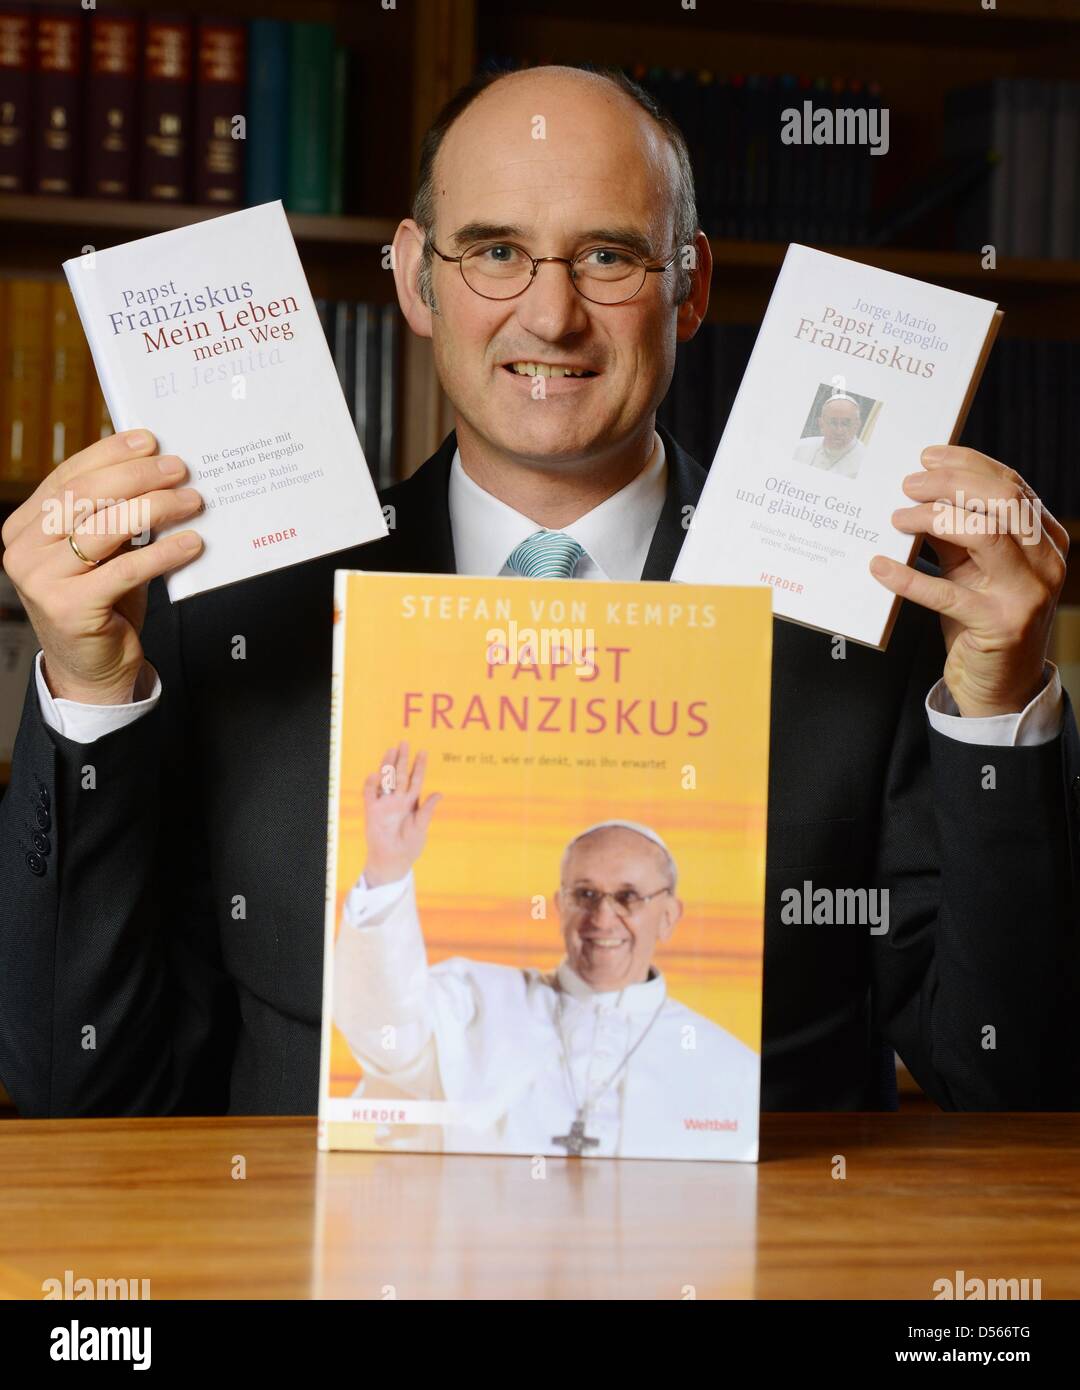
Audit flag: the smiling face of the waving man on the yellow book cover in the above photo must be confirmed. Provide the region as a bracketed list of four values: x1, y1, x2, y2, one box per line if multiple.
[556, 826, 682, 991]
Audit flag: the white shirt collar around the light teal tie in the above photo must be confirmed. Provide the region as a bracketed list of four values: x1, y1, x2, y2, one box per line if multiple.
[449, 432, 667, 580]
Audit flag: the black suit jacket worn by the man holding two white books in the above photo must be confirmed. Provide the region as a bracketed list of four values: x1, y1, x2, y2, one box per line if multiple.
[0, 430, 1080, 1116]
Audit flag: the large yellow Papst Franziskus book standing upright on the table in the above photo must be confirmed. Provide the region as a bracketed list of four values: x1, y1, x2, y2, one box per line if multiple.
[318, 571, 771, 1162]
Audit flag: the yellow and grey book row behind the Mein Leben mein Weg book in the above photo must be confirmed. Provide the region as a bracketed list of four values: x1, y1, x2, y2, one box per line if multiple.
[0, 279, 399, 493]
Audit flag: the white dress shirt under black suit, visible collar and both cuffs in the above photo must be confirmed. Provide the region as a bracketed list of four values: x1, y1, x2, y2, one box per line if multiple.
[35, 435, 1065, 748]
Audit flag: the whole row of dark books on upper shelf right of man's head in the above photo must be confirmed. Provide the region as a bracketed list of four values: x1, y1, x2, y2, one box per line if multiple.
[485, 56, 1080, 260]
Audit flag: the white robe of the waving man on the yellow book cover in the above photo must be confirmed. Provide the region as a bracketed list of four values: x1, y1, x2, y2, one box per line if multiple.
[334, 872, 760, 1162]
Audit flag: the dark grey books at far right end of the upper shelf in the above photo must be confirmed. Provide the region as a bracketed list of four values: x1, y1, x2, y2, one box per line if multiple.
[945, 78, 1080, 260]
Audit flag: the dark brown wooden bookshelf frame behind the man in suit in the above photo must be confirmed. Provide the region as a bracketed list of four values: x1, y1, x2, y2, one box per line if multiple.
[0, 0, 1080, 781]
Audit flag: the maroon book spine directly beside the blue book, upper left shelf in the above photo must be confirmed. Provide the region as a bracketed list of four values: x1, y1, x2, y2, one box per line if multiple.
[195, 19, 247, 207]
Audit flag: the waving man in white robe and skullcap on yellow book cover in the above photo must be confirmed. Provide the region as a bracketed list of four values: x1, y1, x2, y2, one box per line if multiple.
[334, 744, 759, 1159]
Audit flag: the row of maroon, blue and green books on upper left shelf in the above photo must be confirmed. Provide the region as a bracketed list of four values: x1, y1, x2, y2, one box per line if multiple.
[0, 3, 360, 214]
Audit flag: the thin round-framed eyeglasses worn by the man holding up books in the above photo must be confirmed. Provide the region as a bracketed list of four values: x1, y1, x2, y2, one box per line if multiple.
[427, 238, 678, 304]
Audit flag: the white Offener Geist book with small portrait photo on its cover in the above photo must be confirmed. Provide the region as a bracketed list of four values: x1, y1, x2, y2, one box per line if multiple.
[673, 245, 1001, 649]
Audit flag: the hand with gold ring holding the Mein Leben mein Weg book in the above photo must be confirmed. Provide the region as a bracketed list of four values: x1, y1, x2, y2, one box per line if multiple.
[3, 430, 203, 705]
